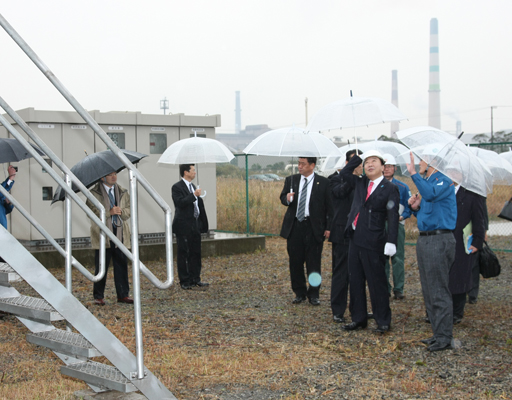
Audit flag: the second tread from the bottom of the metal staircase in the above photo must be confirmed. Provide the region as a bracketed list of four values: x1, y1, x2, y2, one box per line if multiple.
[27, 329, 102, 358]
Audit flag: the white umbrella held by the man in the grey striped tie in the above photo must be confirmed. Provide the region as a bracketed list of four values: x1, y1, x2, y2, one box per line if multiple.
[243, 126, 339, 157]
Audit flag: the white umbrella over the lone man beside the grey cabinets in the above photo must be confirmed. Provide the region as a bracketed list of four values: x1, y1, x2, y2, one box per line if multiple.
[158, 137, 235, 164]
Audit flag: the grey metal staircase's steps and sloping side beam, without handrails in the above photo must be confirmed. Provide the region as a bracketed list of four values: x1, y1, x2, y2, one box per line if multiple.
[0, 230, 176, 399]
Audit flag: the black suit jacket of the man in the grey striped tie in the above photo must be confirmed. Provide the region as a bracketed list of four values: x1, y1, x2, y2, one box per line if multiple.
[280, 174, 332, 242]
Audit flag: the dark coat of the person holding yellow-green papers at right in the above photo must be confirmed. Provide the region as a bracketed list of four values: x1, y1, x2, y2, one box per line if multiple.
[448, 187, 487, 294]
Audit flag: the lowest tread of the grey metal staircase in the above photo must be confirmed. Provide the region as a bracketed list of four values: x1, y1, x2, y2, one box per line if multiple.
[60, 361, 137, 393]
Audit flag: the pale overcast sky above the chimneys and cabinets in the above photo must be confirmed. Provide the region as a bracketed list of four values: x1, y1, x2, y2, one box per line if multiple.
[0, 0, 512, 139]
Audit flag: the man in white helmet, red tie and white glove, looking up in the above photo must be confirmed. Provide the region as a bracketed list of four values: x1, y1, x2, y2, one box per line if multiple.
[341, 150, 400, 333]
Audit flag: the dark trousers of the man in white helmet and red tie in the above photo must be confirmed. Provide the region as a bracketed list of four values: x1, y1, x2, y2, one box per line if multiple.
[348, 240, 391, 326]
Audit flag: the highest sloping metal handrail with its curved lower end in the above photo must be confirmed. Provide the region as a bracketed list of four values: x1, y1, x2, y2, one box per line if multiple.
[0, 14, 174, 289]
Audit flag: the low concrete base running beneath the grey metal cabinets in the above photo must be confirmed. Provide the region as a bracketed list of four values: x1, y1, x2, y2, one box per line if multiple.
[28, 232, 265, 267]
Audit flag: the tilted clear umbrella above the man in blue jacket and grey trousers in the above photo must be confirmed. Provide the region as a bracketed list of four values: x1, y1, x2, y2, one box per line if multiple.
[396, 126, 493, 197]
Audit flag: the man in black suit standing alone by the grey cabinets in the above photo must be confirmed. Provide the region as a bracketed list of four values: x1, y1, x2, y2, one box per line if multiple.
[172, 164, 209, 290]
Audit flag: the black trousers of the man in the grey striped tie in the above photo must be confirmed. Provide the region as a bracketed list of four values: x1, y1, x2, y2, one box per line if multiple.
[286, 218, 324, 299]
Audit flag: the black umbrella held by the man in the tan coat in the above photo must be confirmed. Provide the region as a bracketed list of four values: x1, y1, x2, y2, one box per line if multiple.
[52, 150, 148, 204]
